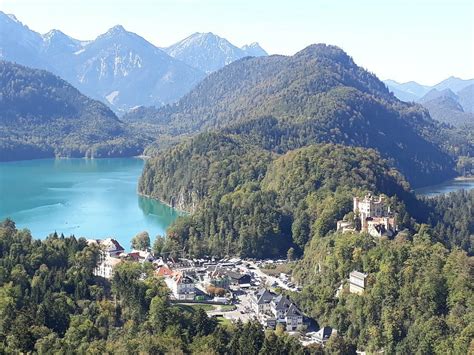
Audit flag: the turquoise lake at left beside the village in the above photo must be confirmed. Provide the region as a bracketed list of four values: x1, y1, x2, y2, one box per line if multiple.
[0, 158, 179, 249]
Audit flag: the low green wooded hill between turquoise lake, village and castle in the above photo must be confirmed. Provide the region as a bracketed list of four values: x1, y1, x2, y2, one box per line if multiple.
[143, 140, 413, 257]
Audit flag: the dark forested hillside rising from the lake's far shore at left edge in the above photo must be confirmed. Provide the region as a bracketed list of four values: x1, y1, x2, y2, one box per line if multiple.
[0, 61, 147, 160]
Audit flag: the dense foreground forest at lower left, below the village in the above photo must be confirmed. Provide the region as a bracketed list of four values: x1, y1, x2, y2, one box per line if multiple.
[0, 220, 322, 354]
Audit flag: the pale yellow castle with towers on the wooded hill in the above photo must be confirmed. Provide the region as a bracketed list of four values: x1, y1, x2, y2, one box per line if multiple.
[337, 194, 398, 237]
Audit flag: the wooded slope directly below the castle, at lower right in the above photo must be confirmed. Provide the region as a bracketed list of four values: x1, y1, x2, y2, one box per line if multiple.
[292, 227, 474, 354]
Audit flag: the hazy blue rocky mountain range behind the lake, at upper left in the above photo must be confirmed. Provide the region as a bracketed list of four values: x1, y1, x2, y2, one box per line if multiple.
[0, 11, 266, 113]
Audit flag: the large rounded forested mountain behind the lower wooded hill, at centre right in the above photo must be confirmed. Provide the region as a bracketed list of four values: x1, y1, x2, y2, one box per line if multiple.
[134, 44, 462, 186]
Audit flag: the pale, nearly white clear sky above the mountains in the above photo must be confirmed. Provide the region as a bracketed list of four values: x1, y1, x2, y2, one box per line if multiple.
[0, 0, 474, 85]
